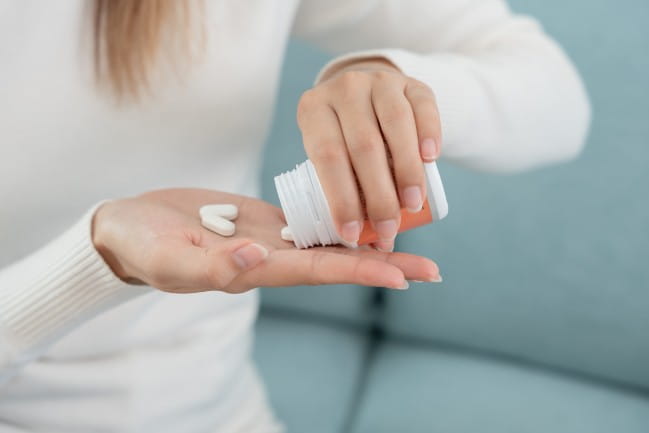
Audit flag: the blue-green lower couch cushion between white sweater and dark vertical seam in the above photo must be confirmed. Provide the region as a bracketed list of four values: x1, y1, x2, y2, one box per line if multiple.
[255, 315, 366, 433]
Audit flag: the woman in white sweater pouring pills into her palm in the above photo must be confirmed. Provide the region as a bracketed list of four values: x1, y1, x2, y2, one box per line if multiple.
[0, 0, 589, 432]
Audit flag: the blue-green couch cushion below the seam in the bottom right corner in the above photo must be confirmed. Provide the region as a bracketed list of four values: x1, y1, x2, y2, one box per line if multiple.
[353, 343, 649, 433]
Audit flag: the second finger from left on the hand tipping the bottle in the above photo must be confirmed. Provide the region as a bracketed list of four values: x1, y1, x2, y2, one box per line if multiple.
[334, 73, 400, 246]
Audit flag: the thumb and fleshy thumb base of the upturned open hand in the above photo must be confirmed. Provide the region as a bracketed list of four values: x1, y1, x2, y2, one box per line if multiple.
[145, 239, 268, 292]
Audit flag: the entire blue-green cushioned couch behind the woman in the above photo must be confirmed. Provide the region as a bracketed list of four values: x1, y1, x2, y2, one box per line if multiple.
[255, 0, 649, 433]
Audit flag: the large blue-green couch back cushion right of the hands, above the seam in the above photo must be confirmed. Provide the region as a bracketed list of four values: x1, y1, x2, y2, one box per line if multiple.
[389, 0, 649, 387]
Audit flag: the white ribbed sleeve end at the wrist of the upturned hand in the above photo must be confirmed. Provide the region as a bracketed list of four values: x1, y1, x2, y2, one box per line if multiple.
[0, 204, 151, 385]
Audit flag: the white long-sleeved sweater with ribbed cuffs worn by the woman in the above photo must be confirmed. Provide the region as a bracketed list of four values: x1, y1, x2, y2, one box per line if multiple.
[0, 0, 590, 433]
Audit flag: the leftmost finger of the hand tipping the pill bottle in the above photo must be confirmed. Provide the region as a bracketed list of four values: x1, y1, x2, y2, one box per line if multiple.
[298, 91, 364, 246]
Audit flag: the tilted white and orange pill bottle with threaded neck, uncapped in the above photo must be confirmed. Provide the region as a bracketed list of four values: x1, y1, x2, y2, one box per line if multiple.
[275, 159, 448, 248]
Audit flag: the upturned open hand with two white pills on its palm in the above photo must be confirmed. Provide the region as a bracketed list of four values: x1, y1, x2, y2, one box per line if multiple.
[93, 189, 439, 293]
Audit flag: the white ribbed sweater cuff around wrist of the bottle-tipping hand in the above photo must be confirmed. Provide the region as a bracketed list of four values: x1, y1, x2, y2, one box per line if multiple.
[315, 49, 482, 157]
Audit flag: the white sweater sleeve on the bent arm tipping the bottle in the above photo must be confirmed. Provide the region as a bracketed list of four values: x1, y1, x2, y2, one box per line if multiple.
[293, 0, 590, 172]
